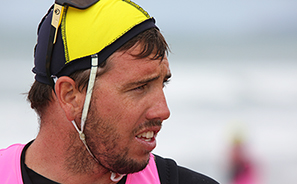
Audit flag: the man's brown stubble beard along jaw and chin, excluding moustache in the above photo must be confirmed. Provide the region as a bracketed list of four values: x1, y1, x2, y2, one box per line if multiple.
[86, 105, 149, 174]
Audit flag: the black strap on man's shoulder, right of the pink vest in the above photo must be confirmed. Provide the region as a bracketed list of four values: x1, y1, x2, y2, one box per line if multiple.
[155, 155, 179, 184]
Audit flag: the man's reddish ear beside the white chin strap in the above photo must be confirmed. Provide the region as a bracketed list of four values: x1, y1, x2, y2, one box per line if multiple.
[55, 76, 85, 121]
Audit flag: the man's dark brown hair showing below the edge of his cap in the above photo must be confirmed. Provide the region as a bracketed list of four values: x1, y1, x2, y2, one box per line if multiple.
[27, 28, 169, 117]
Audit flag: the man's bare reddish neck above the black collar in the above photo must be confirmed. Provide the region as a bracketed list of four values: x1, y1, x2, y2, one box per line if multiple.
[25, 127, 115, 184]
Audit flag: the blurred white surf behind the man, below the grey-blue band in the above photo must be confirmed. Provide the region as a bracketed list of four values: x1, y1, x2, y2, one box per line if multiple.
[0, 53, 297, 184]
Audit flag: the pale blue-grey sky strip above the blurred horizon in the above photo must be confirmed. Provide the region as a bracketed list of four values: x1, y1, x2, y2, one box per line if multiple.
[0, 0, 297, 32]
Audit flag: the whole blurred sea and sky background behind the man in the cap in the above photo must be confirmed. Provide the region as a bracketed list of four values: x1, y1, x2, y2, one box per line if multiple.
[0, 0, 297, 184]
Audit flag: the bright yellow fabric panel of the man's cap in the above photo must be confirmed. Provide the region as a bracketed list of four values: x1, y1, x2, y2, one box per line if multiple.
[61, 0, 151, 63]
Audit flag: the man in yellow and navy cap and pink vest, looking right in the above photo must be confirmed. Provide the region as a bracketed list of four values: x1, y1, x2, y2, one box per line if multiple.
[0, 0, 217, 184]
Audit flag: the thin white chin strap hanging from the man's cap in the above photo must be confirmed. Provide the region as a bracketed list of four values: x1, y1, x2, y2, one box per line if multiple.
[71, 54, 125, 182]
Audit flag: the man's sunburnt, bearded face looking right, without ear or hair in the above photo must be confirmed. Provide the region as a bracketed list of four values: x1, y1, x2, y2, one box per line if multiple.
[85, 46, 171, 174]
